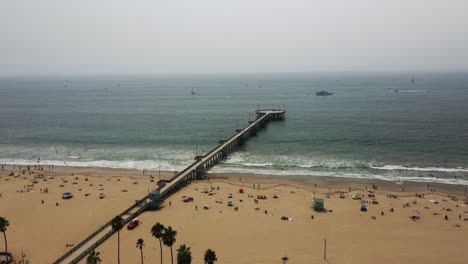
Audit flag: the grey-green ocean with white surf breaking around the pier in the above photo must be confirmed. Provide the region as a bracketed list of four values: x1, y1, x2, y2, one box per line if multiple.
[0, 72, 468, 185]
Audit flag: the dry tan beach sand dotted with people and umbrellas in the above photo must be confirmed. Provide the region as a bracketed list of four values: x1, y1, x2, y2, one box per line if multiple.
[0, 170, 468, 263]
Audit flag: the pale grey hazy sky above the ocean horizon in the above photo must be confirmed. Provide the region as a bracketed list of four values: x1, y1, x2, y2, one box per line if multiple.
[0, 0, 468, 75]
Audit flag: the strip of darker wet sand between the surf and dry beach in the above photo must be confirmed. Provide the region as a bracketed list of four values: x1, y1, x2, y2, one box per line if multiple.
[0, 164, 468, 197]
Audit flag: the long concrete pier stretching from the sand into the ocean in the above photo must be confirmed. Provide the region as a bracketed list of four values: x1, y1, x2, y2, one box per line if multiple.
[53, 109, 286, 264]
